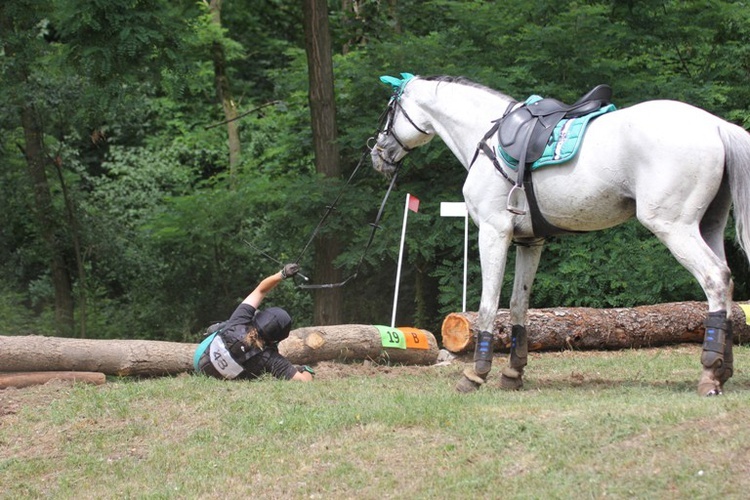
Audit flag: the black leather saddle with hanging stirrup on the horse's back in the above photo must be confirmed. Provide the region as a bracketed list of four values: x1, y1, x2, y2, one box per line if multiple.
[500, 85, 612, 215]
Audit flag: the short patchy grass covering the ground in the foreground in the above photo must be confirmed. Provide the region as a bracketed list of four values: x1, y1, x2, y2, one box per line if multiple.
[0, 346, 750, 499]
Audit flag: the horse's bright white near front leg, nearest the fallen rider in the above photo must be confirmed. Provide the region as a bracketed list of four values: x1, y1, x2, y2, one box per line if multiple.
[456, 214, 513, 392]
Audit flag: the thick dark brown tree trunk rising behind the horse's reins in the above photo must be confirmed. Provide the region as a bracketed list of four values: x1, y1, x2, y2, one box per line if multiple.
[302, 0, 343, 325]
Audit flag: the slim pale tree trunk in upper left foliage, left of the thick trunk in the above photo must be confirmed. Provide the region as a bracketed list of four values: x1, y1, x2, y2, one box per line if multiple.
[208, 0, 241, 188]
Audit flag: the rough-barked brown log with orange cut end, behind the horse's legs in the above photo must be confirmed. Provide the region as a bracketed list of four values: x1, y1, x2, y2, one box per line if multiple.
[441, 302, 750, 353]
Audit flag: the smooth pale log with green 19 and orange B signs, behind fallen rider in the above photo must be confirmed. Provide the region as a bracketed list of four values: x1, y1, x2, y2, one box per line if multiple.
[0, 325, 439, 376]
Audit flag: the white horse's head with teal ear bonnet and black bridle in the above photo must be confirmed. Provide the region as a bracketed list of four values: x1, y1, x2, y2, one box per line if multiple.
[370, 73, 434, 176]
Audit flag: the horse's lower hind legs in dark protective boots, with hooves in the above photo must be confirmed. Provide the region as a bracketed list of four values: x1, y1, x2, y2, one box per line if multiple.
[698, 310, 734, 396]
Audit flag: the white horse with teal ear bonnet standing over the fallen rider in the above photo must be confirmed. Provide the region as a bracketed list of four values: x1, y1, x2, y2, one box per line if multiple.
[371, 73, 750, 396]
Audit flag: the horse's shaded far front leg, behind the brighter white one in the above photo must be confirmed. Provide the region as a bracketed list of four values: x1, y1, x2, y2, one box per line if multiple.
[500, 240, 544, 390]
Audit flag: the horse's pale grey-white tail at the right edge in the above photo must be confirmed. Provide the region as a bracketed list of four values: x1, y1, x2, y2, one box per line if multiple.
[719, 125, 750, 257]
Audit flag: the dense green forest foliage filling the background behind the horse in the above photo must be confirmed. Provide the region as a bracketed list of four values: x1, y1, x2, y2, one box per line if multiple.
[0, 0, 750, 340]
